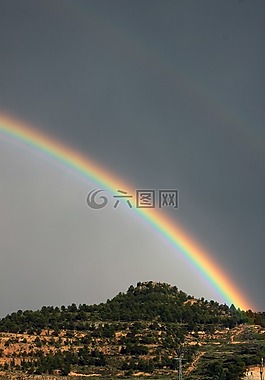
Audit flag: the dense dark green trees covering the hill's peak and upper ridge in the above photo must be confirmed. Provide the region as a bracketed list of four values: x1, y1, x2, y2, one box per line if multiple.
[0, 282, 260, 333]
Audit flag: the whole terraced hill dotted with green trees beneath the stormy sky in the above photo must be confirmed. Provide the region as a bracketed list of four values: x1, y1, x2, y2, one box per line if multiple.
[0, 282, 265, 380]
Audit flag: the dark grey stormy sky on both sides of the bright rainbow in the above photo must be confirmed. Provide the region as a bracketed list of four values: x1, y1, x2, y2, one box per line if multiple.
[0, 0, 265, 315]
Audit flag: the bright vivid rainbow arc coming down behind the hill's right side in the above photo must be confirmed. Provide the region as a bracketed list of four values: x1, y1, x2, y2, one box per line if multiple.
[0, 114, 251, 310]
